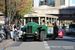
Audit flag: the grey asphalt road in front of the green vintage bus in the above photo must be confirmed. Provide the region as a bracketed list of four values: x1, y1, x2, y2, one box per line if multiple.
[5, 35, 75, 50]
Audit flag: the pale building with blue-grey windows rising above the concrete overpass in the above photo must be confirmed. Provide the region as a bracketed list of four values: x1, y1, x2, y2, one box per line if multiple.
[34, 0, 72, 7]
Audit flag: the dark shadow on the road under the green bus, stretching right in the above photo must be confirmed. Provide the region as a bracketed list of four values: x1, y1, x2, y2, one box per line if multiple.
[17, 38, 75, 42]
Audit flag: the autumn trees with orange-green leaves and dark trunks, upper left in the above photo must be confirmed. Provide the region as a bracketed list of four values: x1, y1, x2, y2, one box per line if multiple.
[0, 0, 33, 23]
